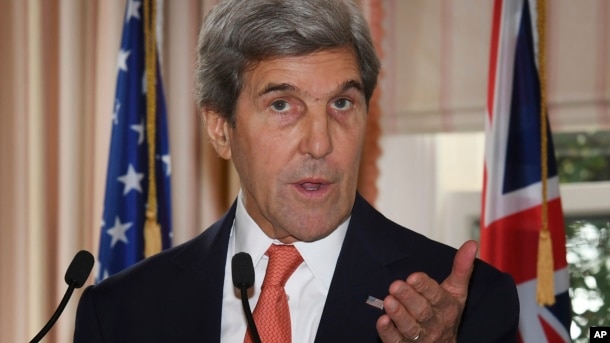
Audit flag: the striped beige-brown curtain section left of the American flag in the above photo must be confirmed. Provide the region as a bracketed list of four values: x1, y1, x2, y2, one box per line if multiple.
[0, 1, 117, 342]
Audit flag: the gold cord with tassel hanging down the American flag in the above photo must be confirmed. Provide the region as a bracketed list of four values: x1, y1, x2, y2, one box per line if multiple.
[144, 0, 162, 257]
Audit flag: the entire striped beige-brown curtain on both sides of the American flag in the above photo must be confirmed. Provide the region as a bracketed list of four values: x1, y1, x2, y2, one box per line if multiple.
[0, 0, 237, 342]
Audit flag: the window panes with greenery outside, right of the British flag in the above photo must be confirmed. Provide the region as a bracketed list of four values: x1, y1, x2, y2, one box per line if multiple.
[553, 131, 610, 342]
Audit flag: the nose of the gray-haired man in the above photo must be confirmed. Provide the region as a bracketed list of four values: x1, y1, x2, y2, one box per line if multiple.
[300, 109, 333, 159]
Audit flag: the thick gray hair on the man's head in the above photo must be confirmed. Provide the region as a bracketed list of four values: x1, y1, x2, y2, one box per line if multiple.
[195, 0, 380, 125]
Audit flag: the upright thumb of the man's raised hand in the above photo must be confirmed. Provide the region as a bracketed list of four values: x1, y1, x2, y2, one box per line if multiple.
[441, 240, 479, 302]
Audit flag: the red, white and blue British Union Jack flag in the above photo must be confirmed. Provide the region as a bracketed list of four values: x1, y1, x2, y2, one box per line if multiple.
[481, 0, 571, 343]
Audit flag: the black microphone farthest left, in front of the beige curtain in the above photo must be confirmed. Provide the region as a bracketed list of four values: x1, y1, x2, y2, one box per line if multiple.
[30, 250, 95, 343]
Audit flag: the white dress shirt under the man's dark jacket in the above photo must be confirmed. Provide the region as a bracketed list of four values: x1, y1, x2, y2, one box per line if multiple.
[220, 192, 349, 343]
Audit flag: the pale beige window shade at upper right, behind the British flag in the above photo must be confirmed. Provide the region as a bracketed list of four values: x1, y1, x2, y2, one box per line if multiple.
[382, 0, 610, 135]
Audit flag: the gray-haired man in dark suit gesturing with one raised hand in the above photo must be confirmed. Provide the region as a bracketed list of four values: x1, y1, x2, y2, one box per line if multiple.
[74, 0, 519, 343]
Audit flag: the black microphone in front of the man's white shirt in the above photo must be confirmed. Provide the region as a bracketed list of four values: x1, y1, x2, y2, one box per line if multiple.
[231, 252, 261, 343]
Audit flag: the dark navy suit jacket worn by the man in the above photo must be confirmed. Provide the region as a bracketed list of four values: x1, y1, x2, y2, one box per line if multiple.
[74, 195, 519, 343]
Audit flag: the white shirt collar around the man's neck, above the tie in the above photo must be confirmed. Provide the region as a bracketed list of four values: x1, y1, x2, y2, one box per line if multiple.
[234, 191, 351, 289]
